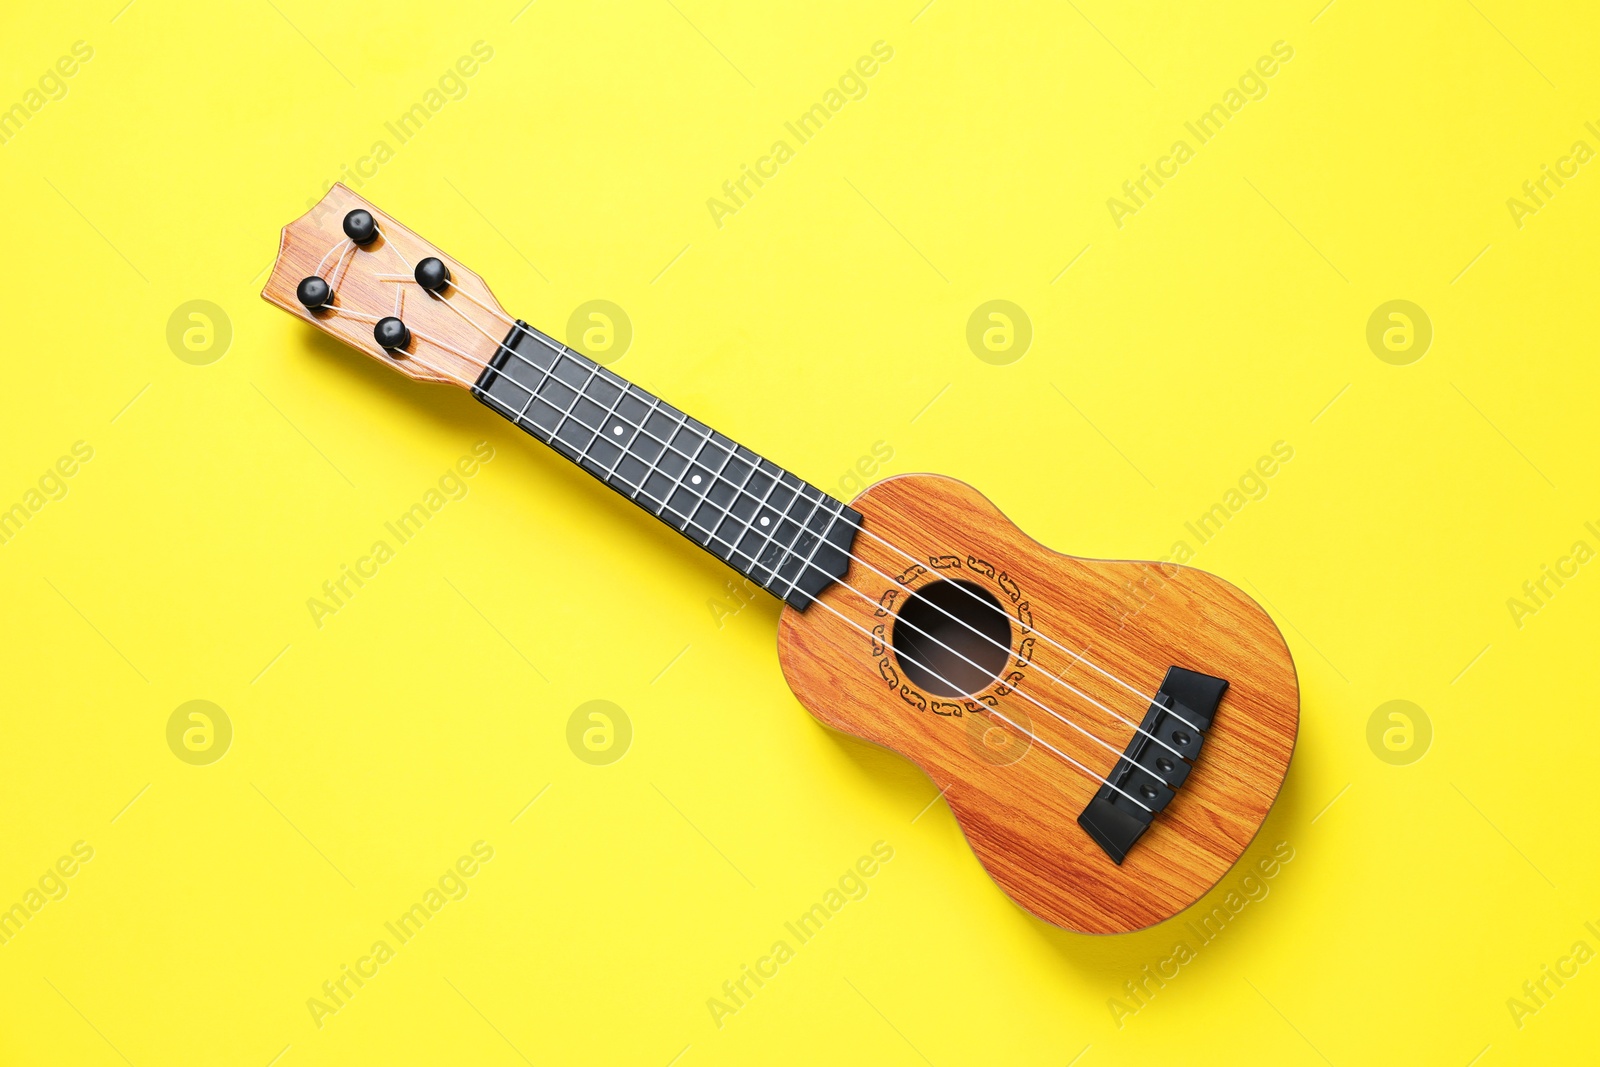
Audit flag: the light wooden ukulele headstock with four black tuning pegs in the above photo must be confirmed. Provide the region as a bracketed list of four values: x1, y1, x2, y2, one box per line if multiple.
[261, 184, 512, 389]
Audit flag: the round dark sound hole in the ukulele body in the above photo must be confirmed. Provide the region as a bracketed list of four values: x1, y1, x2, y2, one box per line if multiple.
[890, 581, 1011, 696]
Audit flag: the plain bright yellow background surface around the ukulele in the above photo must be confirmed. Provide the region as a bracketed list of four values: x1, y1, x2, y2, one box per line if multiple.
[0, 0, 1600, 1067]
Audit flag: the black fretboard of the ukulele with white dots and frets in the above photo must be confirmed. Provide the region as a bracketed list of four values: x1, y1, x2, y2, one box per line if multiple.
[472, 322, 861, 609]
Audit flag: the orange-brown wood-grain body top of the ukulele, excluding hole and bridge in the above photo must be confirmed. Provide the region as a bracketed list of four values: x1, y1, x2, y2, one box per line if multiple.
[778, 475, 1299, 933]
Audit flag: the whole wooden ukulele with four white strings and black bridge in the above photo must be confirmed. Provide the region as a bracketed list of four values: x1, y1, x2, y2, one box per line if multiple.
[262, 186, 1299, 933]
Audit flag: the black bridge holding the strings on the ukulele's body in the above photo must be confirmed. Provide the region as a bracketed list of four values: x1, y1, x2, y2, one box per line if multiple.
[1078, 667, 1227, 864]
